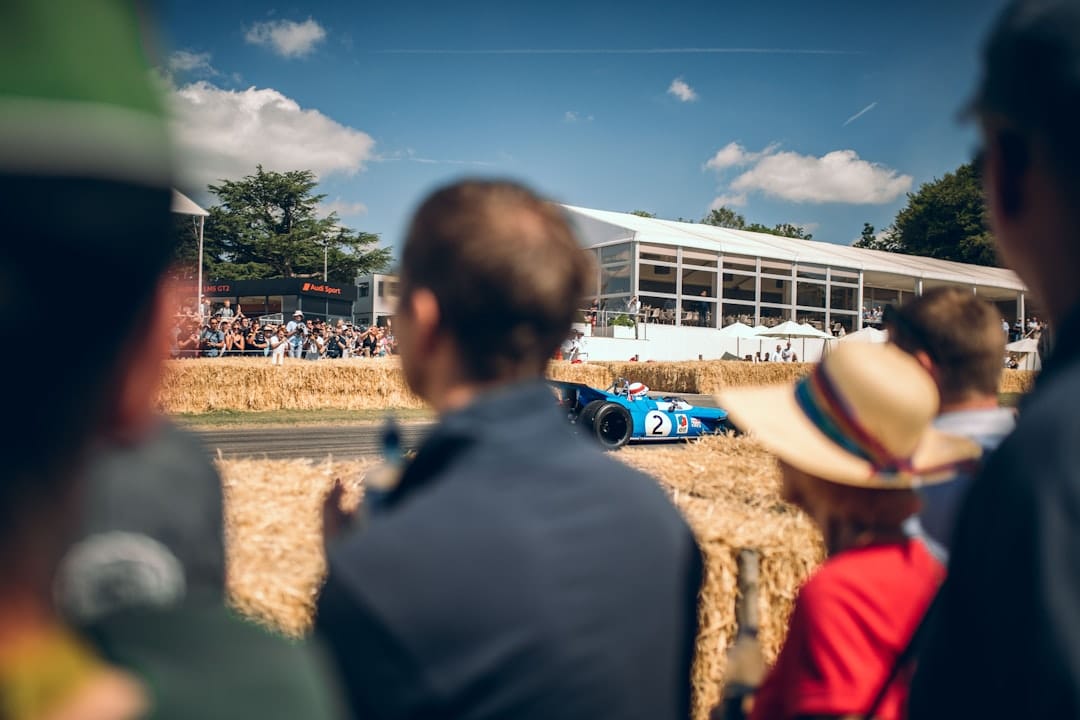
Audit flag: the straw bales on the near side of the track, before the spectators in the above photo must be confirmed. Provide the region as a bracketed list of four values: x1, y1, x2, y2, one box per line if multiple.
[218, 437, 824, 720]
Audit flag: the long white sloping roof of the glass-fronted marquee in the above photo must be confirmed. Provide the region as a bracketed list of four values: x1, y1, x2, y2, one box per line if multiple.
[564, 205, 1027, 291]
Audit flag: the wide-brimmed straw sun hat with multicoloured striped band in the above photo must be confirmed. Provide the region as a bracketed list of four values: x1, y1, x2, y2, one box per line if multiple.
[717, 343, 981, 489]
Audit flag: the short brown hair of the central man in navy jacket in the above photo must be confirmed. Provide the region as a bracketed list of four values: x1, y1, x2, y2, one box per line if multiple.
[401, 180, 592, 381]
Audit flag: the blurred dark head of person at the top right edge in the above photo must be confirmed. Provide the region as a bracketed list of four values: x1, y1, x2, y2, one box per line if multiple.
[972, 0, 1080, 320]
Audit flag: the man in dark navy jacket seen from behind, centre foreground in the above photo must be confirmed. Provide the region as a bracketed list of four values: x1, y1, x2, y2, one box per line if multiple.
[315, 181, 701, 720]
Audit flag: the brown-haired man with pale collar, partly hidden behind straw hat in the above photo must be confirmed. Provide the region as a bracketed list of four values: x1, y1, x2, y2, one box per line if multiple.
[885, 287, 1016, 557]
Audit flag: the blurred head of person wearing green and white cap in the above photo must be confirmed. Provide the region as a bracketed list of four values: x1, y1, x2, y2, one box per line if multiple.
[0, 1, 175, 587]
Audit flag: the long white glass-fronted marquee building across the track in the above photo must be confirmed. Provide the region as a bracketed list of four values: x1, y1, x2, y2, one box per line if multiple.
[565, 206, 1027, 361]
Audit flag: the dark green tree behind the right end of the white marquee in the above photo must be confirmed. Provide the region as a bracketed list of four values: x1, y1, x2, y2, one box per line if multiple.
[855, 163, 1000, 266]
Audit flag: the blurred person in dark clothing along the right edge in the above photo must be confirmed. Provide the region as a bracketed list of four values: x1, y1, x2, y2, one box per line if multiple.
[910, 0, 1080, 719]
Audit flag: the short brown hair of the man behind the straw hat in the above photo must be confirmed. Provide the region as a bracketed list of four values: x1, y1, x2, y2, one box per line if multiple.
[886, 287, 1005, 402]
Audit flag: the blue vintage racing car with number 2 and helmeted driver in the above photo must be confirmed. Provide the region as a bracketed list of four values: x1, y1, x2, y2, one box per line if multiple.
[549, 378, 733, 449]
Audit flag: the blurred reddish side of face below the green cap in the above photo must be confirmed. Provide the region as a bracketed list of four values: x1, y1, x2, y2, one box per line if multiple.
[108, 283, 176, 443]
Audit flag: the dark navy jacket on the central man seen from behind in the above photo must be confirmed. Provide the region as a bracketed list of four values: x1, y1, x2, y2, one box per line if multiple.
[315, 381, 702, 720]
